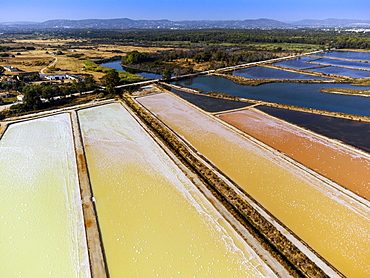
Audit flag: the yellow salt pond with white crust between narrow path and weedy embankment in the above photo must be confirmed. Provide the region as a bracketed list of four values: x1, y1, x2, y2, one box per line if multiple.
[78, 103, 275, 278]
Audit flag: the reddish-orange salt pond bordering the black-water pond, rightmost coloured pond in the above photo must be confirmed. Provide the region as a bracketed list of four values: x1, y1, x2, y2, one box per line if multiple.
[219, 109, 370, 200]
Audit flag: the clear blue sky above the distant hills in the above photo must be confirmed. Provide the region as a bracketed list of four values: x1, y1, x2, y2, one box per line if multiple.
[0, 0, 370, 22]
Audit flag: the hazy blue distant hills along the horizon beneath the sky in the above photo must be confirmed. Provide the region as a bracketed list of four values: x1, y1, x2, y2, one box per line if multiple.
[0, 18, 370, 30]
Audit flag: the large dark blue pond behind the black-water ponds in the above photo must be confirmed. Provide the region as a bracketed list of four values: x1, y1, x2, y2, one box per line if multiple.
[173, 76, 370, 116]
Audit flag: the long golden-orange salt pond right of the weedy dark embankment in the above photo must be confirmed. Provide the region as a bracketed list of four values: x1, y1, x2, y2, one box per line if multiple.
[137, 93, 370, 277]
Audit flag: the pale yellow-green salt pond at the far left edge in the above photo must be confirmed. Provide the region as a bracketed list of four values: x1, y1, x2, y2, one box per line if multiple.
[0, 114, 90, 278]
